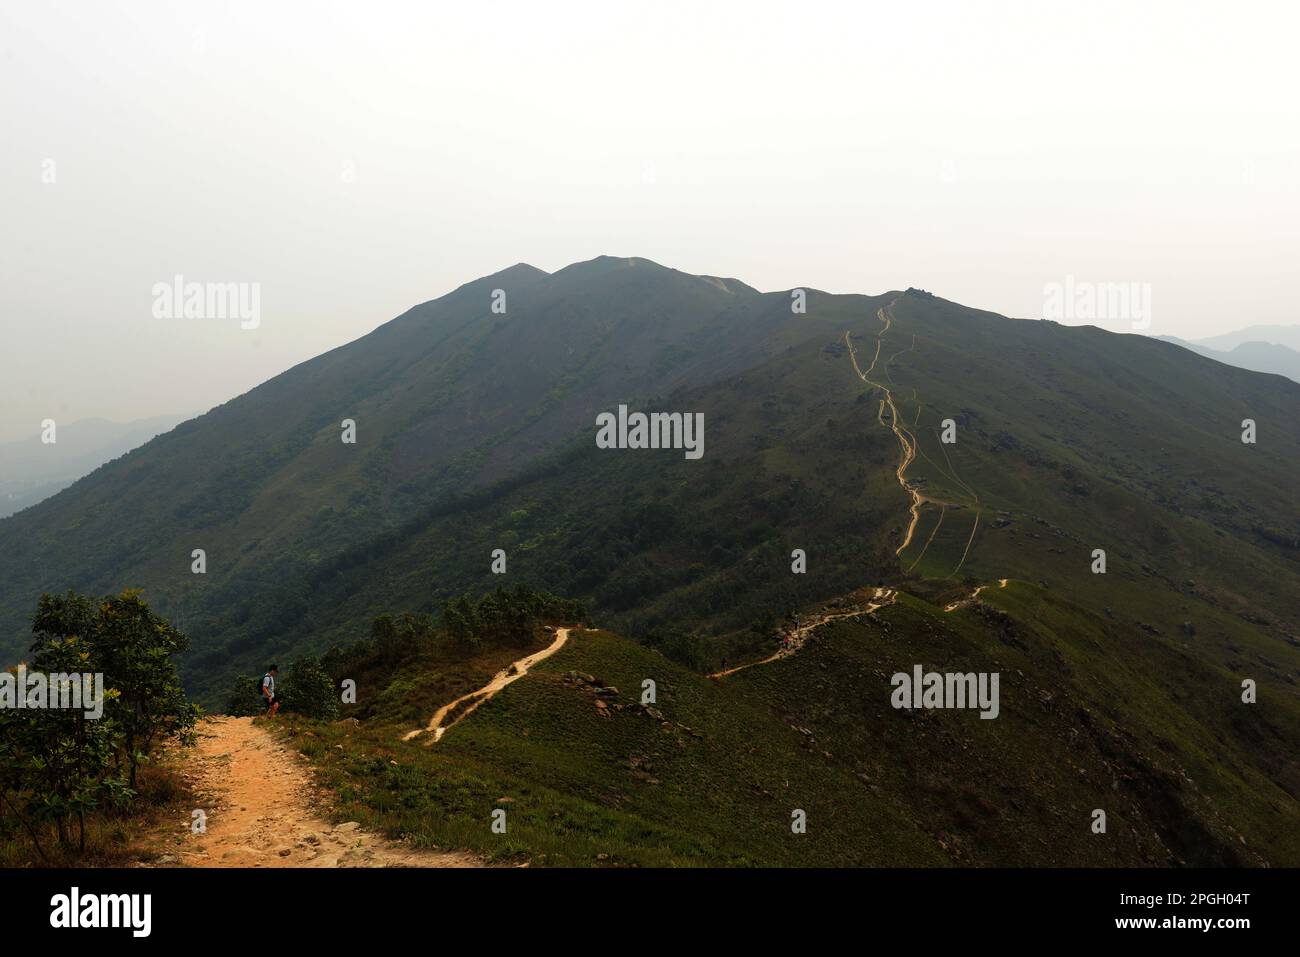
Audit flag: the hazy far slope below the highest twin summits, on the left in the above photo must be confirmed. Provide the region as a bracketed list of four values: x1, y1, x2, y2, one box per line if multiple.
[0, 257, 875, 681]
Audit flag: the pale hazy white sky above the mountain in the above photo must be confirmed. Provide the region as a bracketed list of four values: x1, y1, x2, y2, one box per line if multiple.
[0, 0, 1300, 438]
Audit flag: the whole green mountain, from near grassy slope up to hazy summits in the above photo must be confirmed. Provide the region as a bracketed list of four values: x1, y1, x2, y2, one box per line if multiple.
[0, 257, 1300, 865]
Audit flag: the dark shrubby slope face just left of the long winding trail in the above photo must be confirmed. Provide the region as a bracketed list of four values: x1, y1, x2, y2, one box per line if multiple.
[269, 325, 906, 664]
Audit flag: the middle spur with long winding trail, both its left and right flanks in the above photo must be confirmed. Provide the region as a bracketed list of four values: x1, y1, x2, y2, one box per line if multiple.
[228, 294, 1300, 702]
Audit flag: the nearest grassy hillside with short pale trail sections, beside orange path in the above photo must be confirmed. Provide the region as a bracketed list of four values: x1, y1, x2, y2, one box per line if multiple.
[287, 583, 1300, 866]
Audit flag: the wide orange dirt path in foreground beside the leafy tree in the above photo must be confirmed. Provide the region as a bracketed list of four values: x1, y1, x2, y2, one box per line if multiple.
[157, 716, 482, 867]
